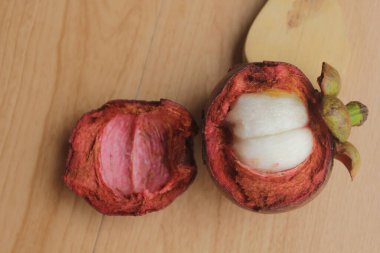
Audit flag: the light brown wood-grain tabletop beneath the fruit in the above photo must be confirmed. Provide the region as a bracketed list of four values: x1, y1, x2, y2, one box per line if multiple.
[0, 0, 380, 253]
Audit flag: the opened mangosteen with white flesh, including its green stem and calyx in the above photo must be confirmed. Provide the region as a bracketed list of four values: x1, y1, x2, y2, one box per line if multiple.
[203, 62, 368, 212]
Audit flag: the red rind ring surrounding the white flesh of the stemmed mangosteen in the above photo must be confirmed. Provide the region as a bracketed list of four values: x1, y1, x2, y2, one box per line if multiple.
[202, 62, 334, 213]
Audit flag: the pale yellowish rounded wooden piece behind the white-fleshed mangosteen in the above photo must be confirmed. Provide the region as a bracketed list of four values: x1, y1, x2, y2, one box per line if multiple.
[244, 0, 352, 81]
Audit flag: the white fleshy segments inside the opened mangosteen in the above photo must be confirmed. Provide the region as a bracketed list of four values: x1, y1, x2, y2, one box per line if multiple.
[227, 93, 313, 172]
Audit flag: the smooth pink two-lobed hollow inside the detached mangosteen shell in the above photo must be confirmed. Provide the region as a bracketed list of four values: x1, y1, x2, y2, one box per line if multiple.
[100, 112, 169, 195]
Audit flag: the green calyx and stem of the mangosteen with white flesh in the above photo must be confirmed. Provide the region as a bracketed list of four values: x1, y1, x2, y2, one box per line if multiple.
[318, 63, 368, 179]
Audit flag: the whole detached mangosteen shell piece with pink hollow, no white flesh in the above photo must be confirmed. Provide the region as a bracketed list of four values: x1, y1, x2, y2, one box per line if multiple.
[64, 100, 197, 215]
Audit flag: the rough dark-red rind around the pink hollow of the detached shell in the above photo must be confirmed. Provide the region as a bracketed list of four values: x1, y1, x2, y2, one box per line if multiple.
[64, 99, 197, 215]
